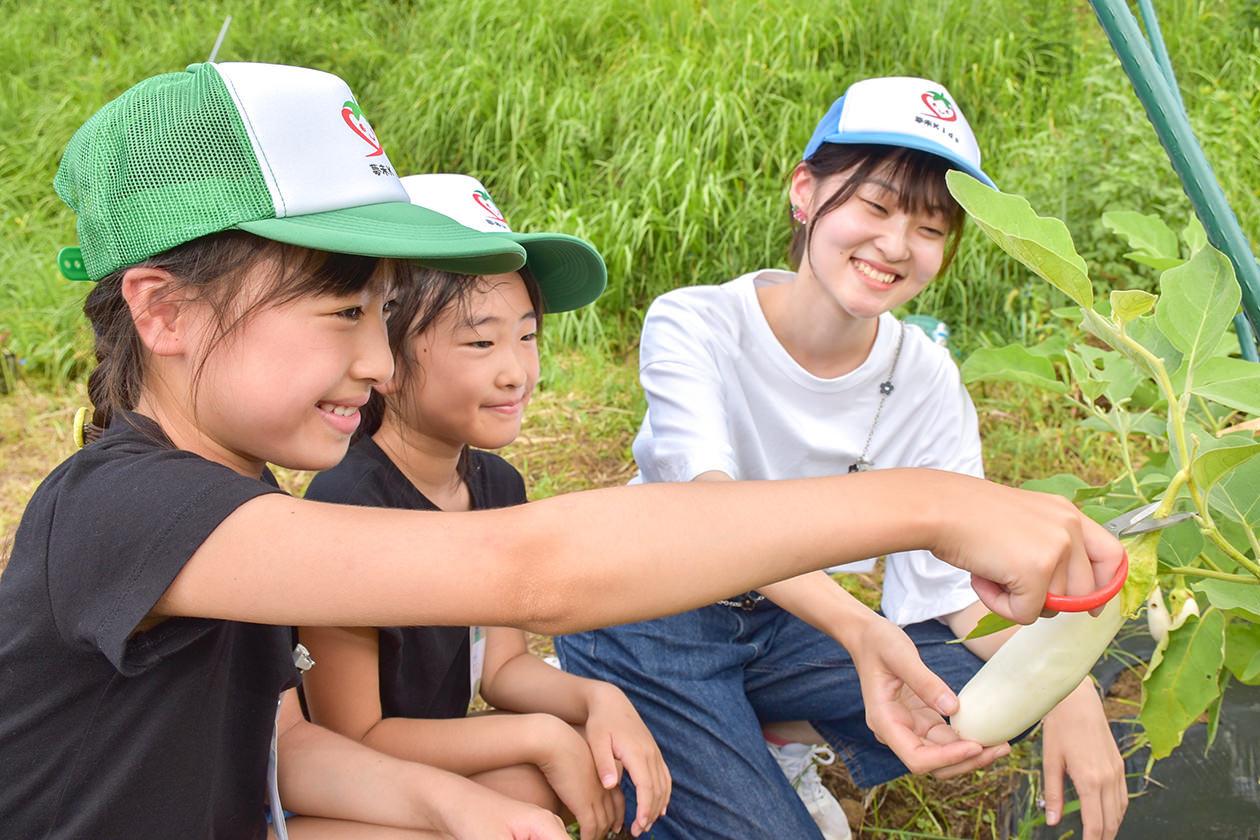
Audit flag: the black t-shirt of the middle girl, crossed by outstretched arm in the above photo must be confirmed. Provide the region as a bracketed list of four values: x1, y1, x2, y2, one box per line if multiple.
[306, 437, 525, 718]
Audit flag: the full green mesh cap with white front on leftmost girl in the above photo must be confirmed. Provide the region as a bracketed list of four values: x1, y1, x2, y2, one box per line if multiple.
[53, 63, 525, 280]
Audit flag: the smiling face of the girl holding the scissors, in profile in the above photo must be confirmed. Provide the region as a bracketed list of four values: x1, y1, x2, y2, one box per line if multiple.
[156, 253, 393, 475]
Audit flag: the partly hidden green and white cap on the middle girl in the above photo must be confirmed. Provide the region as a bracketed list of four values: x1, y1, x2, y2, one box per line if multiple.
[402, 173, 609, 312]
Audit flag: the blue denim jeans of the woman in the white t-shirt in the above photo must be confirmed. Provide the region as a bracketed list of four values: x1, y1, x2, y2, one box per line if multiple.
[556, 601, 982, 840]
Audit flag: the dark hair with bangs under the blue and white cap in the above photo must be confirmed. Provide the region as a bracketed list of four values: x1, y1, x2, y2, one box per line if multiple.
[788, 144, 966, 273]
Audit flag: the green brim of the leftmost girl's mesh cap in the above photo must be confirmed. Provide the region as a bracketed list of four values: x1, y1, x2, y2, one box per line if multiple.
[236, 201, 525, 275]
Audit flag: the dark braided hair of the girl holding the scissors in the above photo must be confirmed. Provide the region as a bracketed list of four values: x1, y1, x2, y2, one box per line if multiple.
[83, 230, 386, 429]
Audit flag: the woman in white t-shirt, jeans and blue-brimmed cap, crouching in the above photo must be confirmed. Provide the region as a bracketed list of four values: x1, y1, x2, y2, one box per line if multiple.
[557, 78, 1126, 840]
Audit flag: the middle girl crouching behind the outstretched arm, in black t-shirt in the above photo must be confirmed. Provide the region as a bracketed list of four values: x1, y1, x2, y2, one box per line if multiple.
[301, 174, 669, 839]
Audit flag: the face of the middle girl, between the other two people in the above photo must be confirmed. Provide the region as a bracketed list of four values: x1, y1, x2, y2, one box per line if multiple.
[379, 272, 539, 451]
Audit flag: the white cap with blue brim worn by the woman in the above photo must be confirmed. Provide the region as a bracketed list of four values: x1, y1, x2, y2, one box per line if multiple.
[801, 76, 997, 189]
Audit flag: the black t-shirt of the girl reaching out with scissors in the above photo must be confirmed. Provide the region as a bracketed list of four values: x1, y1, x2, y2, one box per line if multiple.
[0, 414, 296, 840]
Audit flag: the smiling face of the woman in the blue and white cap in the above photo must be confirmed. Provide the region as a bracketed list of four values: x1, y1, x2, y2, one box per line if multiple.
[791, 165, 953, 319]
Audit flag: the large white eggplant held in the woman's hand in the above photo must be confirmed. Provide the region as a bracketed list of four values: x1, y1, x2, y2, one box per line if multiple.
[950, 597, 1124, 746]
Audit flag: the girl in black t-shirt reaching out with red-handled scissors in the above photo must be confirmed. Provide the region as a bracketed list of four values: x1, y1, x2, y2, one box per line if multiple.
[0, 64, 1123, 840]
